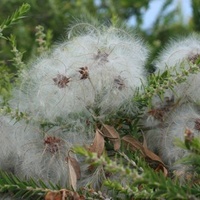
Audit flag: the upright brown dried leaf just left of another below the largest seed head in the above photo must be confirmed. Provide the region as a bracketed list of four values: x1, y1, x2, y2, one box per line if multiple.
[88, 129, 105, 157]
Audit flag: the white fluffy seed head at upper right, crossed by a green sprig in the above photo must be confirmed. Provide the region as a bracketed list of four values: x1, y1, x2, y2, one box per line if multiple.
[148, 34, 200, 117]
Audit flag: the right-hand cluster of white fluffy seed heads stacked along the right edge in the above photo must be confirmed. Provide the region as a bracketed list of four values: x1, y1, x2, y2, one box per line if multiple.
[143, 35, 200, 179]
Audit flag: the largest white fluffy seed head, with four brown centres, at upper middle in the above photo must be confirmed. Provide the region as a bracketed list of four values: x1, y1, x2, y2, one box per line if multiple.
[12, 23, 147, 121]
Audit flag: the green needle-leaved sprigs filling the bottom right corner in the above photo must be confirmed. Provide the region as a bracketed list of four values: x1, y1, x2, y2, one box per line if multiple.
[74, 147, 200, 199]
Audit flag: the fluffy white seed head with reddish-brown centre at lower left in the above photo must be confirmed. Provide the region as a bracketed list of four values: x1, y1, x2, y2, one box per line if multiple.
[16, 124, 78, 186]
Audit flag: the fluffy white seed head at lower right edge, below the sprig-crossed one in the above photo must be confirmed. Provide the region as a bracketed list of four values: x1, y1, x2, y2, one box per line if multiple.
[159, 105, 200, 168]
